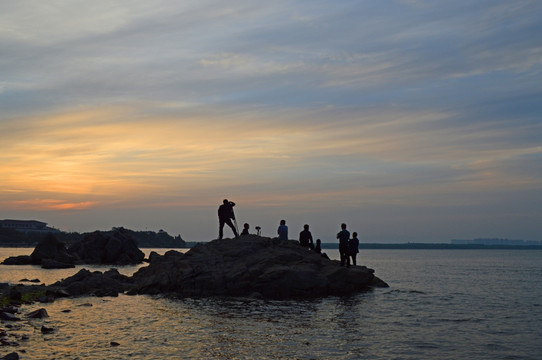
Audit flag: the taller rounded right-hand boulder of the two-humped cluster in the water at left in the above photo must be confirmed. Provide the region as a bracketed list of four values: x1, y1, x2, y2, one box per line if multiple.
[69, 228, 145, 265]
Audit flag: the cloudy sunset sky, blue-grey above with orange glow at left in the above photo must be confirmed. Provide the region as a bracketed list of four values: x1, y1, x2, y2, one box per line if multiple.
[0, 0, 542, 243]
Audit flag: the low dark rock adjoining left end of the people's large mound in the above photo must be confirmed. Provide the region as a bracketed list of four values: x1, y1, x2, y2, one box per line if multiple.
[48, 269, 131, 296]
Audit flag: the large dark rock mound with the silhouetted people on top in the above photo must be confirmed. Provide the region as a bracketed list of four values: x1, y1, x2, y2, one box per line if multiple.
[132, 235, 387, 299]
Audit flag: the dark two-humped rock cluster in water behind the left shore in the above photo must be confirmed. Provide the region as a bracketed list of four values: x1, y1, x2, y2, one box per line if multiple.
[3, 228, 145, 269]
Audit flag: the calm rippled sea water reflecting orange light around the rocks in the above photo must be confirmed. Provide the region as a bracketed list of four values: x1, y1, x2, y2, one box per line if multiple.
[0, 248, 542, 360]
